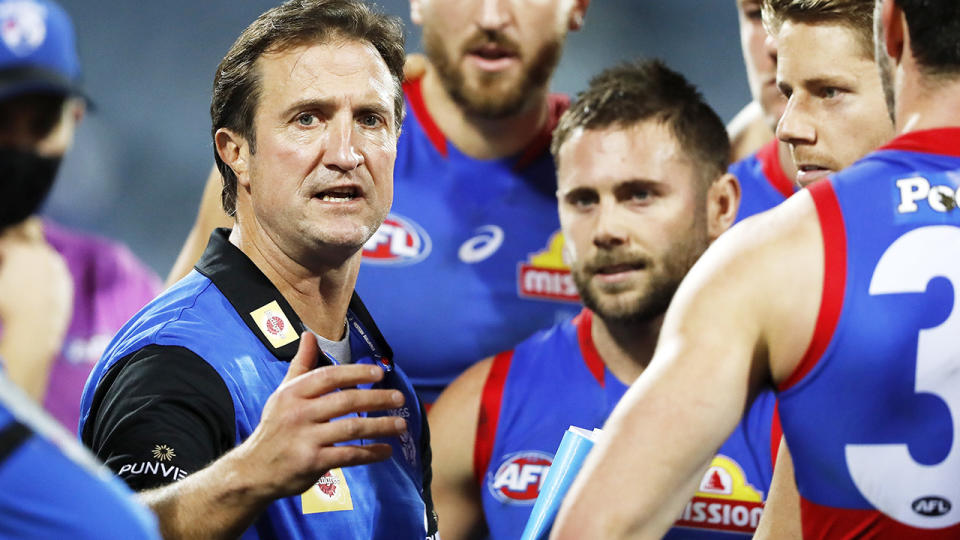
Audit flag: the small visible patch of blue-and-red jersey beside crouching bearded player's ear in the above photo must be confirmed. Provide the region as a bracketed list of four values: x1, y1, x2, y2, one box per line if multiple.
[729, 139, 796, 222]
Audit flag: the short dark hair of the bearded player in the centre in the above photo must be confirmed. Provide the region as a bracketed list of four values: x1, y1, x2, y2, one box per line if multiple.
[550, 60, 730, 181]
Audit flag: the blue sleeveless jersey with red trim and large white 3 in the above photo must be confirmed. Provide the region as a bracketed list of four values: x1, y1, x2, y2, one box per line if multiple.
[780, 129, 960, 539]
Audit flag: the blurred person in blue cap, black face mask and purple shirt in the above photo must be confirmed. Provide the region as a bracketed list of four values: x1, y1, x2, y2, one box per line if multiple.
[0, 0, 160, 430]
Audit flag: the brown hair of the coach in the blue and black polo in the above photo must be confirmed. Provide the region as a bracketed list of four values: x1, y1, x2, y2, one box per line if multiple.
[210, 0, 404, 216]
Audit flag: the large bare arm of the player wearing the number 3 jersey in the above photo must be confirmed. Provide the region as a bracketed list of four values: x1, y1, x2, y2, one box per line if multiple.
[553, 188, 823, 538]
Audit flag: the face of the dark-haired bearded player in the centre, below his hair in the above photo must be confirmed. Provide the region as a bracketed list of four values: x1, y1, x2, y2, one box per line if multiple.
[557, 121, 709, 321]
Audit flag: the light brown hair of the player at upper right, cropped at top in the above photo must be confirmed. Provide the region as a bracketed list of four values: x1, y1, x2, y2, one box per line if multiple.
[760, 0, 875, 58]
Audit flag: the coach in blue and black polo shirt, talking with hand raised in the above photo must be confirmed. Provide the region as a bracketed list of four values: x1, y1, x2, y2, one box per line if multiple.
[80, 0, 436, 539]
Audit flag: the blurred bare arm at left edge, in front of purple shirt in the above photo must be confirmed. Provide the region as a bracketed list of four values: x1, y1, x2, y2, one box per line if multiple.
[0, 220, 73, 397]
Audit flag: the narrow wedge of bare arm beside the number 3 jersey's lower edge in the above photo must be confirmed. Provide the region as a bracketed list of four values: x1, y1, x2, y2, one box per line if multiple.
[753, 439, 803, 540]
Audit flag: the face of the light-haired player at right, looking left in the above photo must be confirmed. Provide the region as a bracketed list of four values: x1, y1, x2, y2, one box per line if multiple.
[777, 21, 893, 186]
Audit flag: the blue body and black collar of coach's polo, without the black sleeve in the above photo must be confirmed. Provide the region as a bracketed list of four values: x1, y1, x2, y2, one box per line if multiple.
[80, 229, 436, 540]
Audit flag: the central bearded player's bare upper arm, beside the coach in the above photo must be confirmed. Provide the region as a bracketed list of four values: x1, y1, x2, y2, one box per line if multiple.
[429, 358, 493, 540]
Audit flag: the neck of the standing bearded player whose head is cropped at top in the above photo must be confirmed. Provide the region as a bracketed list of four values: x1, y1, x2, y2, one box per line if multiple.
[421, 67, 548, 159]
